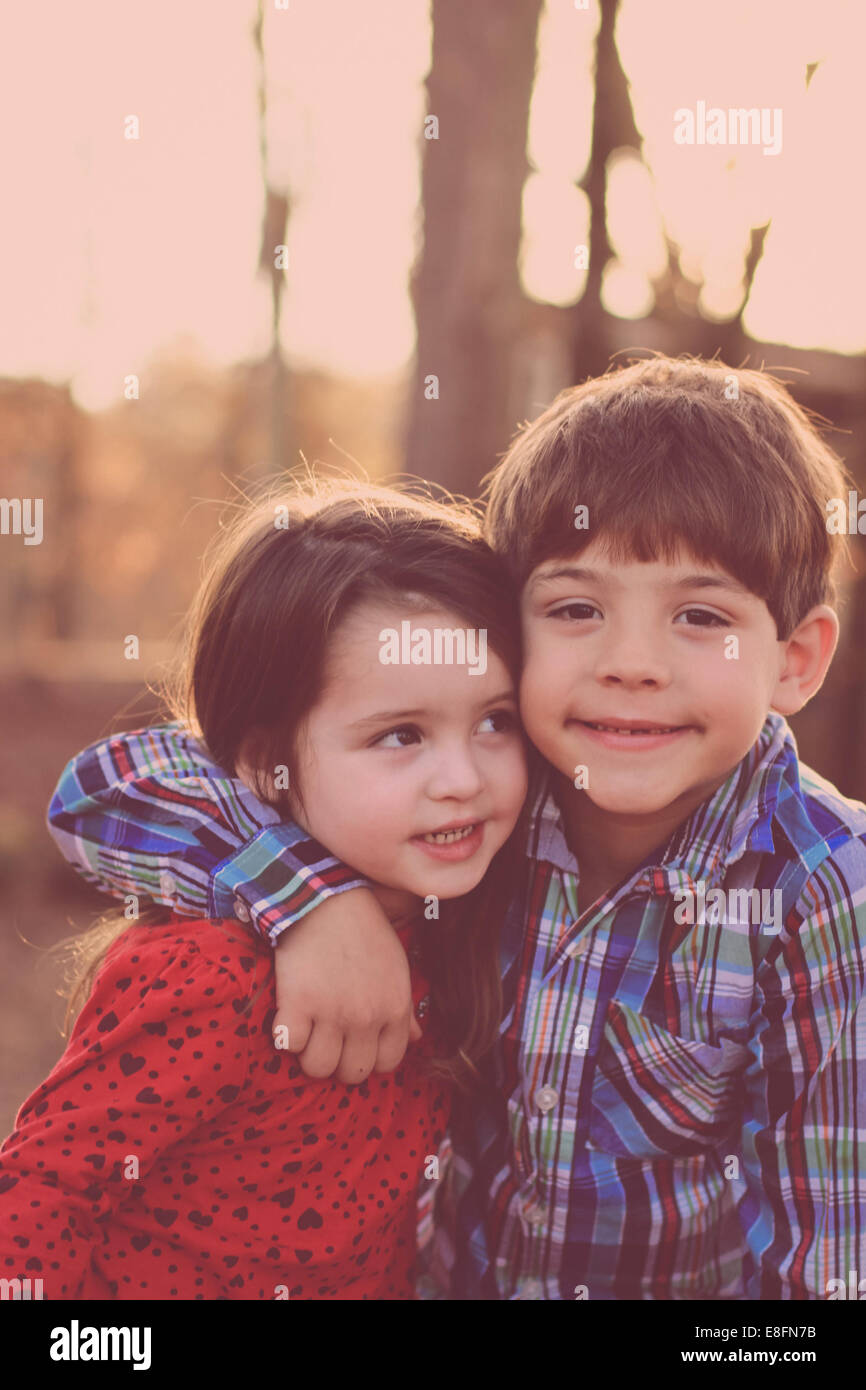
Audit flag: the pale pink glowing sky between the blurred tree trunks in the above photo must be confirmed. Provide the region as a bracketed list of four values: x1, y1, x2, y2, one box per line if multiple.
[0, 0, 866, 409]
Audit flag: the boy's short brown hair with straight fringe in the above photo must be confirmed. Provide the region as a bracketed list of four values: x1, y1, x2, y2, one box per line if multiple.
[485, 356, 852, 641]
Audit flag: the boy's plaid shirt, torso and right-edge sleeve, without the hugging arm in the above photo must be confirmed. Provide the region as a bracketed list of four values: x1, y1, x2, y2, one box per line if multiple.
[439, 714, 866, 1300]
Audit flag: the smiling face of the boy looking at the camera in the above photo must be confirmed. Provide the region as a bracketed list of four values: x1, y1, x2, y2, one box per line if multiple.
[520, 541, 785, 842]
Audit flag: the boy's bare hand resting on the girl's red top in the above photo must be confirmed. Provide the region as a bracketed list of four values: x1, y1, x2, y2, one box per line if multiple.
[274, 888, 421, 1084]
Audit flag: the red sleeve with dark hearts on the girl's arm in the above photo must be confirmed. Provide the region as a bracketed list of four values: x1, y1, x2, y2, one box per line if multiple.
[0, 935, 250, 1300]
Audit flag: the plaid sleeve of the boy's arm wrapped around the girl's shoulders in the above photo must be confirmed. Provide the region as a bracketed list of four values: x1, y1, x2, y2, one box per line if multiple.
[47, 721, 368, 945]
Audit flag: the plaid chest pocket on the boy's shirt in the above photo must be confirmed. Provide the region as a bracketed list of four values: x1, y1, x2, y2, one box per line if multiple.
[587, 999, 749, 1158]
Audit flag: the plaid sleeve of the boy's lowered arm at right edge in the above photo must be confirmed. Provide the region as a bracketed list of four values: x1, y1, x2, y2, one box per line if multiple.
[738, 841, 866, 1300]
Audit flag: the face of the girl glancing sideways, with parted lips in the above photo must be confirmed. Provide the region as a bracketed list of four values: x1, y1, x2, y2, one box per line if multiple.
[284, 600, 527, 912]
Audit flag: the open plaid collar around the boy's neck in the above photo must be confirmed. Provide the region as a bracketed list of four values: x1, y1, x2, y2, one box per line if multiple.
[527, 713, 796, 892]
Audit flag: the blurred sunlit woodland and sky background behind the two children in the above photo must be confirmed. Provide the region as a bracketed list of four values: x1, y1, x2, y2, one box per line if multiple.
[0, 0, 866, 1131]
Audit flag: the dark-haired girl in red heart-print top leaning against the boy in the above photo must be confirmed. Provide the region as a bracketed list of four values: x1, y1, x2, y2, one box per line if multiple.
[0, 484, 527, 1300]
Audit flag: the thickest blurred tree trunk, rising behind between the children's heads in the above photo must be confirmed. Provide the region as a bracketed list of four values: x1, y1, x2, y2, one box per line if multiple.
[406, 0, 541, 493]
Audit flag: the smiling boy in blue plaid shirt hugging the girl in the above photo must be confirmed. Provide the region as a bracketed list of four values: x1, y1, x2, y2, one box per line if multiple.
[50, 357, 866, 1300]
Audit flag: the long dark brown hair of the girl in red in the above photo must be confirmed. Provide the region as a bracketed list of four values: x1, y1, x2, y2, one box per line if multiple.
[57, 478, 521, 1087]
